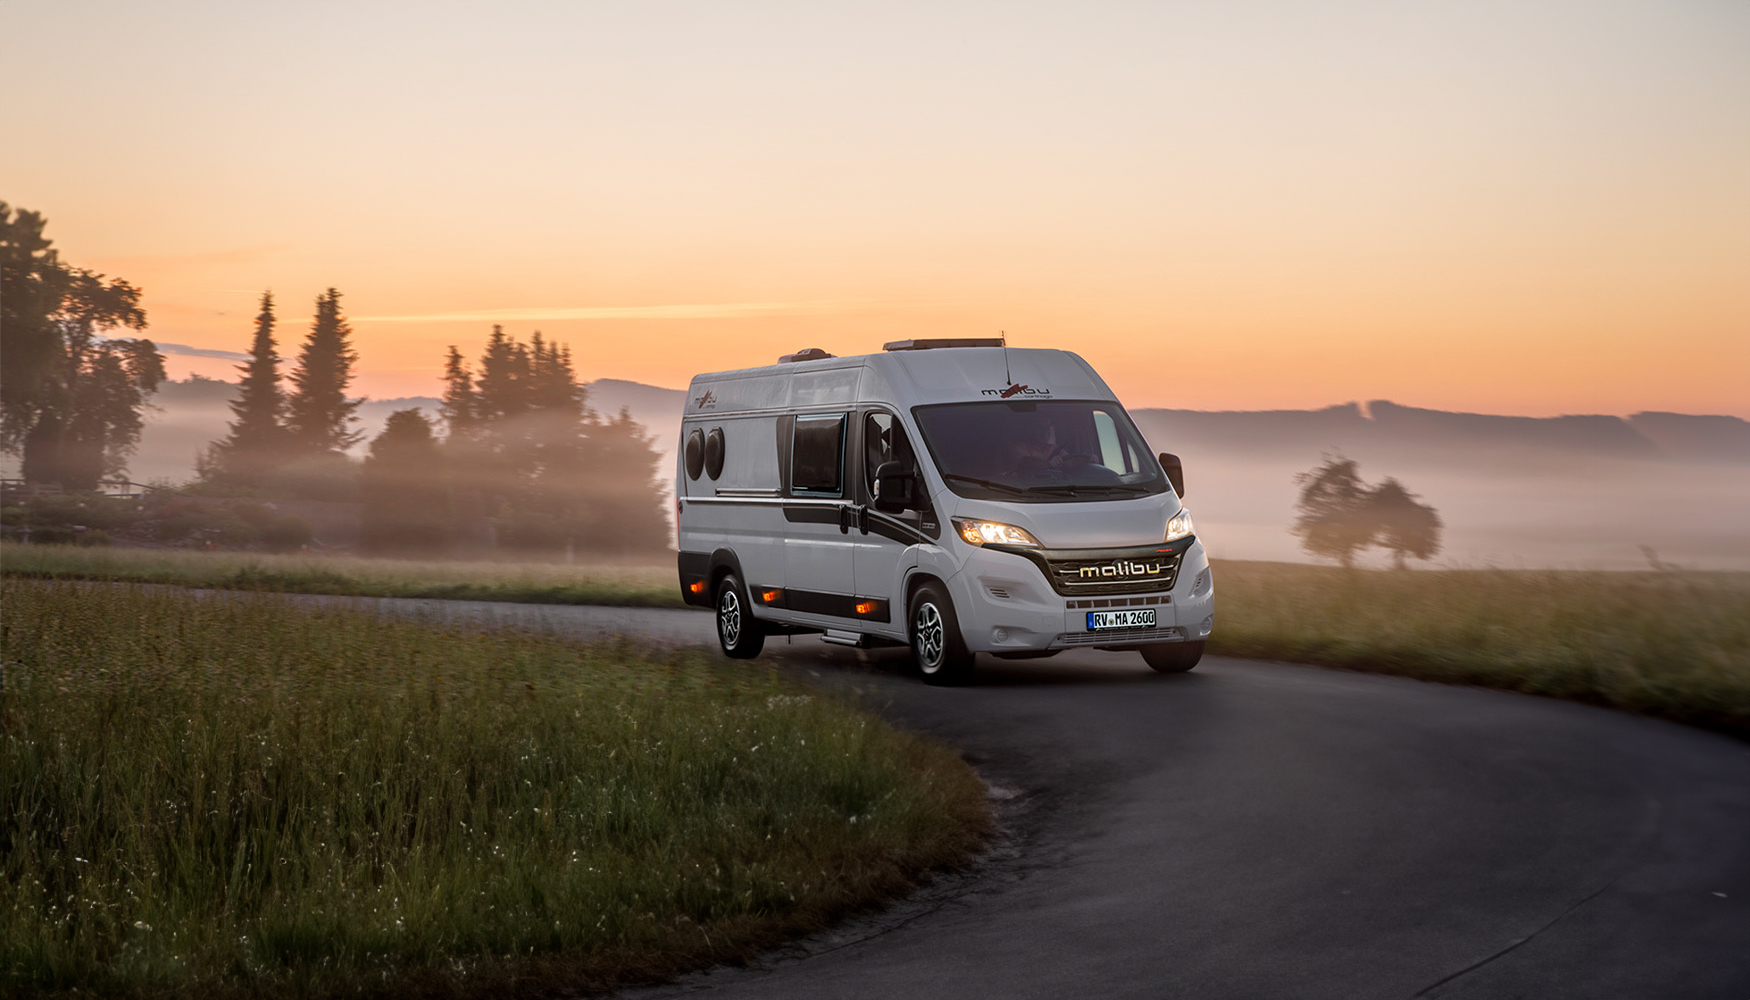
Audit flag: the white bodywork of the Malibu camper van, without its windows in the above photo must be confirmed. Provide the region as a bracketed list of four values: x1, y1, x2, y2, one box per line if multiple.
[676, 347, 1213, 653]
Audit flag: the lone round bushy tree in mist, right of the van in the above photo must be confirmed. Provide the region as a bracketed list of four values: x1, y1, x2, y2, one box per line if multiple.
[1290, 455, 1442, 569]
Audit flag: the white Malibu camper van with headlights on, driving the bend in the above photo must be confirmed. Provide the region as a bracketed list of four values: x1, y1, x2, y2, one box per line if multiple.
[674, 340, 1215, 683]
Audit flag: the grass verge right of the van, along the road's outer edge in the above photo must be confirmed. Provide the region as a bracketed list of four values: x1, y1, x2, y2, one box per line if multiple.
[1209, 562, 1750, 737]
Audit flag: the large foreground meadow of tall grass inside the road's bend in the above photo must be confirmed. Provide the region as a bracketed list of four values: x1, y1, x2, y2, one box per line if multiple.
[0, 580, 987, 996]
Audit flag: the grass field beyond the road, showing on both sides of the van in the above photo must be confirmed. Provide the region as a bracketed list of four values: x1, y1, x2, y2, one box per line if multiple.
[0, 545, 1750, 736]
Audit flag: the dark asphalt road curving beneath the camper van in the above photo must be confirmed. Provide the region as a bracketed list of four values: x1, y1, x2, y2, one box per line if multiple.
[355, 602, 1750, 1000]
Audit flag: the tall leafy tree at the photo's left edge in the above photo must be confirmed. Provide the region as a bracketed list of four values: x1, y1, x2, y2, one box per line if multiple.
[0, 201, 165, 489]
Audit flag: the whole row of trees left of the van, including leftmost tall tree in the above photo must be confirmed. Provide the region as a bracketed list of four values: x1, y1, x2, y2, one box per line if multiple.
[0, 201, 669, 553]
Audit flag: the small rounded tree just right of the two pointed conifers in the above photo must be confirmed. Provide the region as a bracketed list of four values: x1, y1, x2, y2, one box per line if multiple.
[359, 408, 450, 553]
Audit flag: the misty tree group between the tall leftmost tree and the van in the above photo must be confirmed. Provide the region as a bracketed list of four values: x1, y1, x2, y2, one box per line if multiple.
[198, 289, 669, 553]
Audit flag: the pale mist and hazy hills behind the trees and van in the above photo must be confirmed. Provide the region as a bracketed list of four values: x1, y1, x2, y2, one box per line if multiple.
[30, 378, 1750, 569]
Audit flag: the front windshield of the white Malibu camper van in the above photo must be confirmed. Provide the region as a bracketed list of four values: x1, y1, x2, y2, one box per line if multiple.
[912, 399, 1167, 503]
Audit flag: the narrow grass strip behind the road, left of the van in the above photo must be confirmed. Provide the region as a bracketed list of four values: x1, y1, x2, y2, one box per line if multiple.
[0, 543, 683, 608]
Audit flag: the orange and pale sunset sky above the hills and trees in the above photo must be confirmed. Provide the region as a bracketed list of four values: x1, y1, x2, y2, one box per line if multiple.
[0, 0, 1750, 417]
